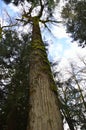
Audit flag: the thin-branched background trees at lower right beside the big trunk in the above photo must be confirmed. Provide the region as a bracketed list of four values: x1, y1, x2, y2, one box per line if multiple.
[53, 57, 86, 130]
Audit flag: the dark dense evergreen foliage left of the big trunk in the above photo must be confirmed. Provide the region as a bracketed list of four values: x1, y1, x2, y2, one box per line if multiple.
[0, 30, 30, 130]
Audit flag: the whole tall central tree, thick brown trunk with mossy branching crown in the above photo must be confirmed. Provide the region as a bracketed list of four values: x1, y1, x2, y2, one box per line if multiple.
[1, 0, 63, 130]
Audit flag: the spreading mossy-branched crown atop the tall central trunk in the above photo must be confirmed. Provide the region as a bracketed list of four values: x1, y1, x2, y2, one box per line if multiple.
[3, 0, 60, 27]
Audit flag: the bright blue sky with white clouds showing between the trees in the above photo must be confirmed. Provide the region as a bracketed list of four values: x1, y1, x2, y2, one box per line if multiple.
[0, 0, 86, 130]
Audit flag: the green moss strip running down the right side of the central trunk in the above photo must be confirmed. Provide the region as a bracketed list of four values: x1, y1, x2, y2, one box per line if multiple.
[32, 39, 57, 92]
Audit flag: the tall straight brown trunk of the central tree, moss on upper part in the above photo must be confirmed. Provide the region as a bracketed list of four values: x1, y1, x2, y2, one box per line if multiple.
[27, 18, 63, 130]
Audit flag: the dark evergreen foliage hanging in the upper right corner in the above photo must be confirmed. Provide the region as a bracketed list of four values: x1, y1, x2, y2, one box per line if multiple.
[62, 0, 86, 47]
